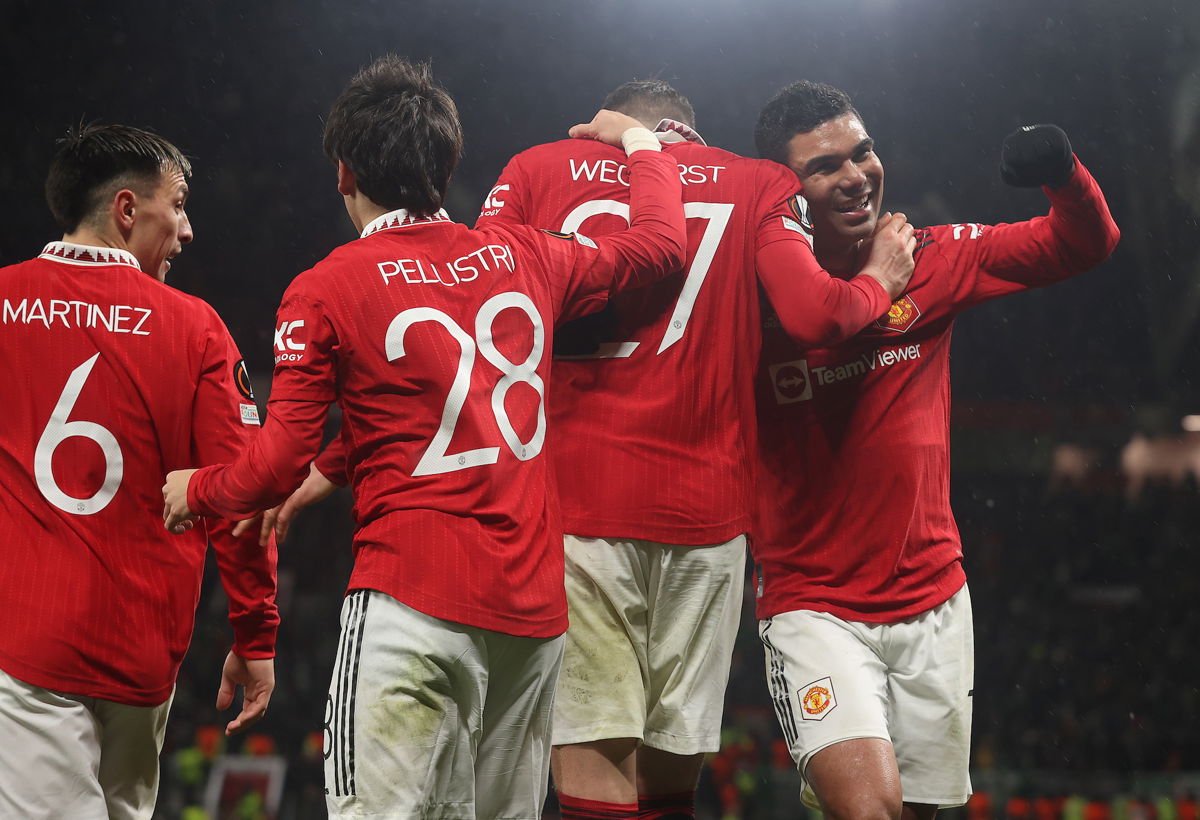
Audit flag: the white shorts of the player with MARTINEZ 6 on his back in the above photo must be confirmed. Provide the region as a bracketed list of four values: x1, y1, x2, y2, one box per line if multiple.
[0, 671, 170, 820]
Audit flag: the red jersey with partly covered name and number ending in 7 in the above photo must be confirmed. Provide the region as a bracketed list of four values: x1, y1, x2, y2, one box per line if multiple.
[478, 126, 888, 545]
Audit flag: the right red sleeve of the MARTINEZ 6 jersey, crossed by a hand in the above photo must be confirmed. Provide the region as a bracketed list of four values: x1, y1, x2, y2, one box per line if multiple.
[192, 315, 280, 658]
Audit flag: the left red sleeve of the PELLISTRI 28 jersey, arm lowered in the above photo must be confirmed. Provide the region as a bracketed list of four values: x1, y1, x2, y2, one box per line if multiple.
[187, 280, 338, 519]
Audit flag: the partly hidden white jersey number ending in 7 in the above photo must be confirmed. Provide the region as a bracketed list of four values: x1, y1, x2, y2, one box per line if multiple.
[562, 199, 733, 359]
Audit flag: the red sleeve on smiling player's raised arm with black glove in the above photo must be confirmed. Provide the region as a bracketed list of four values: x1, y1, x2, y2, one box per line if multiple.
[935, 157, 1121, 306]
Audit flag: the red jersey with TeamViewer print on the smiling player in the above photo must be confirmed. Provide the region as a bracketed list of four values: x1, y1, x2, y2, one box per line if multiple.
[754, 164, 1120, 623]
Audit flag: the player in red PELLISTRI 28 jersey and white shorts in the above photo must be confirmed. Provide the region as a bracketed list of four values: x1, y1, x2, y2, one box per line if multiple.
[164, 56, 685, 818]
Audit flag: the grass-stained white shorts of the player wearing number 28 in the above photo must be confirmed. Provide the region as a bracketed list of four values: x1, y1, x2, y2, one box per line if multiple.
[324, 589, 563, 820]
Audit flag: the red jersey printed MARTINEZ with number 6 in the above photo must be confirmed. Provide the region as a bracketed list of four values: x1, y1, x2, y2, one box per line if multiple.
[0, 243, 278, 706]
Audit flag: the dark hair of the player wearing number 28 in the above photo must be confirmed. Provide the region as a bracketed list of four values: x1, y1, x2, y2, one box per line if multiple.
[324, 54, 462, 216]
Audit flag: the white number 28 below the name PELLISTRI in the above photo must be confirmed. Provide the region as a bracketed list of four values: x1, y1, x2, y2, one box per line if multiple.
[384, 291, 546, 475]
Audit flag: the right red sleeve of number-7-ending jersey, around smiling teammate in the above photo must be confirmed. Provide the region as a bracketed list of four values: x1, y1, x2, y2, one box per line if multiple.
[755, 167, 890, 347]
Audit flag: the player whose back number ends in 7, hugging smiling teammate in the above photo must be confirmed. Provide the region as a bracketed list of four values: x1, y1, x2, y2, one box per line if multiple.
[478, 80, 912, 818]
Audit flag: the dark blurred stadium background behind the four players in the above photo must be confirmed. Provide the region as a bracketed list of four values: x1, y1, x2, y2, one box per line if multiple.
[0, 0, 1200, 820]
